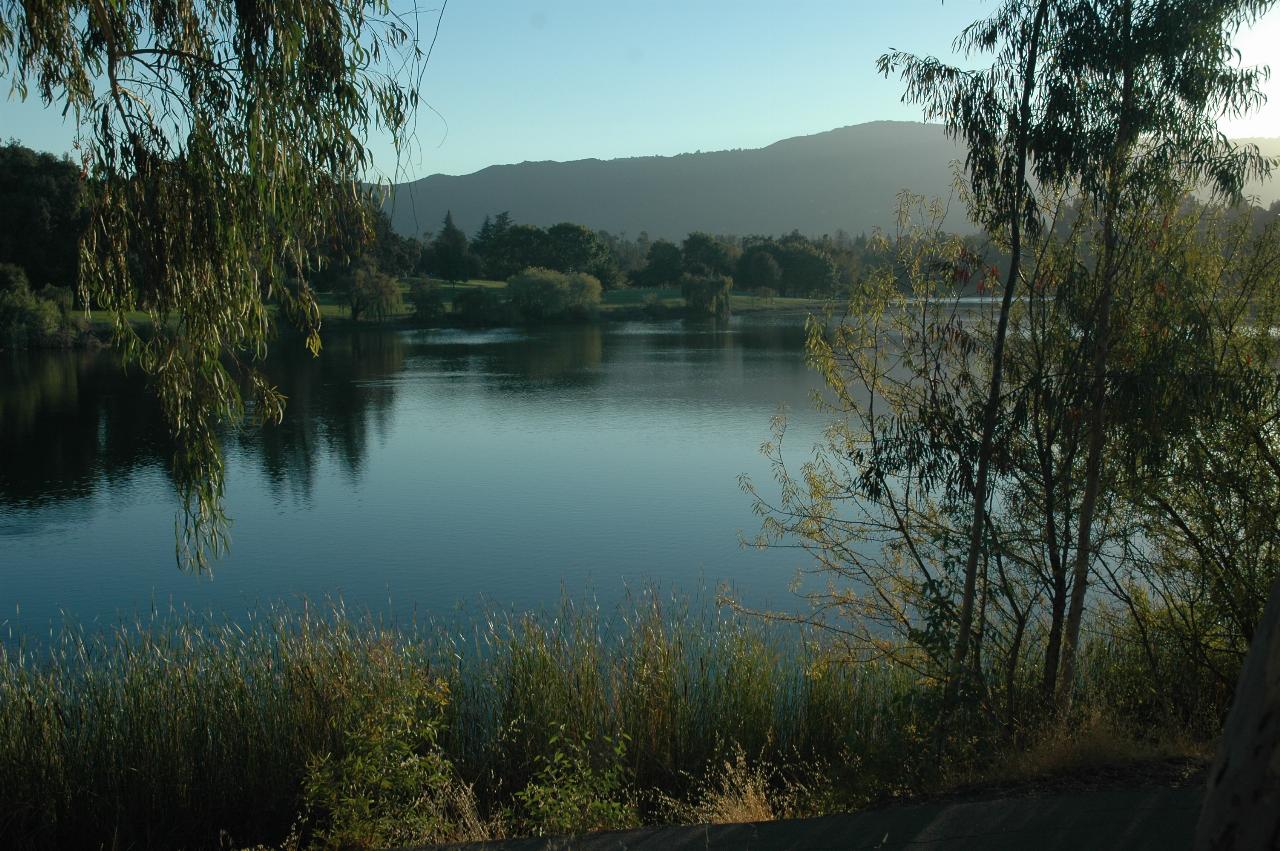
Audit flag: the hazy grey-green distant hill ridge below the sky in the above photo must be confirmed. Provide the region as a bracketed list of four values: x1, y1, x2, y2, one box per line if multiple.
[387, 122, 1280, 239]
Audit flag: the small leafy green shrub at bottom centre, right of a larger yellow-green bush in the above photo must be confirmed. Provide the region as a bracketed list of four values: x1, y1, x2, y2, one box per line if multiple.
[506, 724, 639, 836]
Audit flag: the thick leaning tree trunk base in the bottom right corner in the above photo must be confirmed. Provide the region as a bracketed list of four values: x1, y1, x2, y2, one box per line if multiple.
[1196, 580, 1280, 851]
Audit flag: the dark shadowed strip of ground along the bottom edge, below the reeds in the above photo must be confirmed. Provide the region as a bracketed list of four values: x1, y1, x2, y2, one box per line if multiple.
[414, 763, 1204, 851]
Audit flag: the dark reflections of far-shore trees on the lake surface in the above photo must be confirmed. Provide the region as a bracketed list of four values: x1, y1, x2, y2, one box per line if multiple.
[0, 314, 804, 508]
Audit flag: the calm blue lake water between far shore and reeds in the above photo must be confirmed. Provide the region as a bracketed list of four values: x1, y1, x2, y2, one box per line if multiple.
[0, 316, 820, 636]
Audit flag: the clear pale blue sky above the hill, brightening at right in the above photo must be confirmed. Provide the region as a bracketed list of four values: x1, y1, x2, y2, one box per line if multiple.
[0, 0, 1280, 180]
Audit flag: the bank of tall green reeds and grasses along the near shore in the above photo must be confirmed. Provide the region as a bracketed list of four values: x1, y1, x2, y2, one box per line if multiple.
[0, 598, 1212, 847]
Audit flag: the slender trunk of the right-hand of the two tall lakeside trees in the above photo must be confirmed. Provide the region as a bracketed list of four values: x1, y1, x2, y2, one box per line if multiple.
[1057, 21, 1133, 715]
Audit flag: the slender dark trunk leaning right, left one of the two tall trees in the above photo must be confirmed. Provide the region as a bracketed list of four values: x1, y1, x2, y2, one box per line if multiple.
[938, 0, 1048, 744]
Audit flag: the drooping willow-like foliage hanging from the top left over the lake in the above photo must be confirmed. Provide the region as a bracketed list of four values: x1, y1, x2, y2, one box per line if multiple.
[0, 0, 426, 569]
